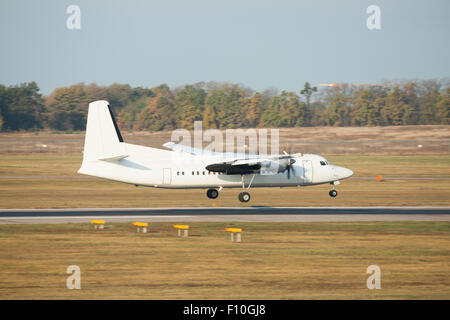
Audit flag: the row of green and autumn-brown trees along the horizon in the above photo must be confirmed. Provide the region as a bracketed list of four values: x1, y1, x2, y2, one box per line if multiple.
[0, 80, 450, 131]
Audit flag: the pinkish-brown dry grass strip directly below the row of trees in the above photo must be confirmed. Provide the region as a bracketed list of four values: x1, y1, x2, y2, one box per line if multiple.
[0, 125, 450, 154]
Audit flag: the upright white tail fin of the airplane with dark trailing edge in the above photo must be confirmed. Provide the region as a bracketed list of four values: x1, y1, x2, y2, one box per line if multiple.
[83, 100, 127, 160]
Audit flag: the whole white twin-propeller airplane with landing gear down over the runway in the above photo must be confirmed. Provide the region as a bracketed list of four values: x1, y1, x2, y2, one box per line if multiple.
[78, 101, 353, 202]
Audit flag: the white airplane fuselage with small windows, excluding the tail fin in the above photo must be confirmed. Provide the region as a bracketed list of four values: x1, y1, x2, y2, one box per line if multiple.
[79, 144, 353, 189]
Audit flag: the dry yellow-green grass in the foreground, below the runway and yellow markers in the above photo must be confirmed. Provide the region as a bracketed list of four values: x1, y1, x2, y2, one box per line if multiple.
[0, 221, 450, 299]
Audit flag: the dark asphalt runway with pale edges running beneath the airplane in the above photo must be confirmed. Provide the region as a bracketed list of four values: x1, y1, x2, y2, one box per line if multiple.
[0, 207, 450, 224]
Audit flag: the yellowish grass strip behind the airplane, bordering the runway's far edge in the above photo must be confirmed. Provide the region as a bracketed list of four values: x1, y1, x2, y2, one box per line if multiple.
[0, 153, 450, 208]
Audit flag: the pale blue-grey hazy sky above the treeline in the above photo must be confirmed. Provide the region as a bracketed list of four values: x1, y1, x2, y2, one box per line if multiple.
[0, 0, 450, 94]
